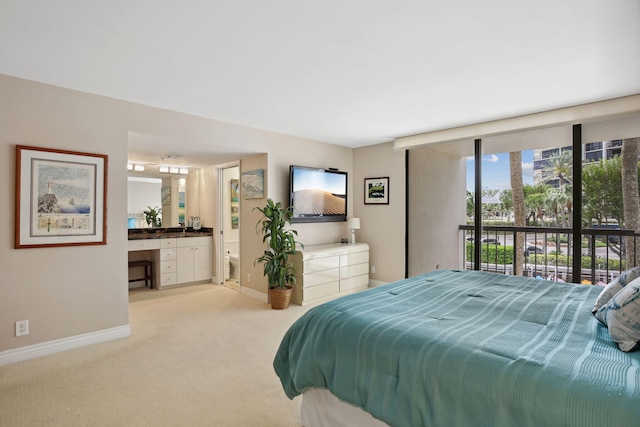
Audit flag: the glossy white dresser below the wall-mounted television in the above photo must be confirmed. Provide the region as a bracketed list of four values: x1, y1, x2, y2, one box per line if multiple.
[291, 243, 369, 305]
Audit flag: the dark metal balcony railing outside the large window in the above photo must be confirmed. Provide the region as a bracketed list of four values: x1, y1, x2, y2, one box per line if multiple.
[460, 225, 640, 285]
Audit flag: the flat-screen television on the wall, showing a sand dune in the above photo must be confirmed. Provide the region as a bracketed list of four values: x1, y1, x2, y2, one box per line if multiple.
[289, 165, 347, 222]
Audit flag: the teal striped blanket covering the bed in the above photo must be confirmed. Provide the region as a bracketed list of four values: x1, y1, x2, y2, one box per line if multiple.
[273, 270, 640, 427]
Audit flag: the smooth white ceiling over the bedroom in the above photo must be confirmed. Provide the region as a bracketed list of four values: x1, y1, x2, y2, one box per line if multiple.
[0, 0, 640, 165]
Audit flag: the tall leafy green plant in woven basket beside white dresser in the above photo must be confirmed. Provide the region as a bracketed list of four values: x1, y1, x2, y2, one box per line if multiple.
[254, 199, 302, 310]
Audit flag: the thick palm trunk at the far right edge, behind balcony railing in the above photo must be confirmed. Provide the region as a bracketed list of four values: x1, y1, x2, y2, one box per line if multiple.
[620, 138, 640, 266]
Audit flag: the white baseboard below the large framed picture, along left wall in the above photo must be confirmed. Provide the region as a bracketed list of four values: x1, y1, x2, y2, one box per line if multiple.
[0, 324, 131, 366]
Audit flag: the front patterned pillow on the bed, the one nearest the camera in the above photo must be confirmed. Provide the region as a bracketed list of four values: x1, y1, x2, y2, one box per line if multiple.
[595, 277, 640, 351]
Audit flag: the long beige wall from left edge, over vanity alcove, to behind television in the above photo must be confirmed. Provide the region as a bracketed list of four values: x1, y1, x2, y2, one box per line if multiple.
[0, 75, 370, 356]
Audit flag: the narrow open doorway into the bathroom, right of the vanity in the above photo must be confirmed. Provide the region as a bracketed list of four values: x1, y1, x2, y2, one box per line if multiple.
[218, 162, 241, 291]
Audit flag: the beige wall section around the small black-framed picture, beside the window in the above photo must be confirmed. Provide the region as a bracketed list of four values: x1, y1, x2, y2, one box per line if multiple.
[351, 142, 406, 284]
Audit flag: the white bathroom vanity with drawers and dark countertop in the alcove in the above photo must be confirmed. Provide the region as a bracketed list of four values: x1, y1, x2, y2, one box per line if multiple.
[129, 227, 213, 289]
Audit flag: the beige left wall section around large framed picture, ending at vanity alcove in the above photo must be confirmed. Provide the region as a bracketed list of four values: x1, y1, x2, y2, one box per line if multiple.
[0, 76, 129, 351]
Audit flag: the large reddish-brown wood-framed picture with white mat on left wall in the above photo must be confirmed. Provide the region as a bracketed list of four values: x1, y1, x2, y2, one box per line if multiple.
[15, 145, 109, 249]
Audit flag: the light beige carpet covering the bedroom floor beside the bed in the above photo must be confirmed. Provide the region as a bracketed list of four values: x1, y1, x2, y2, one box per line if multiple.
[0, 284, 308, 427]
